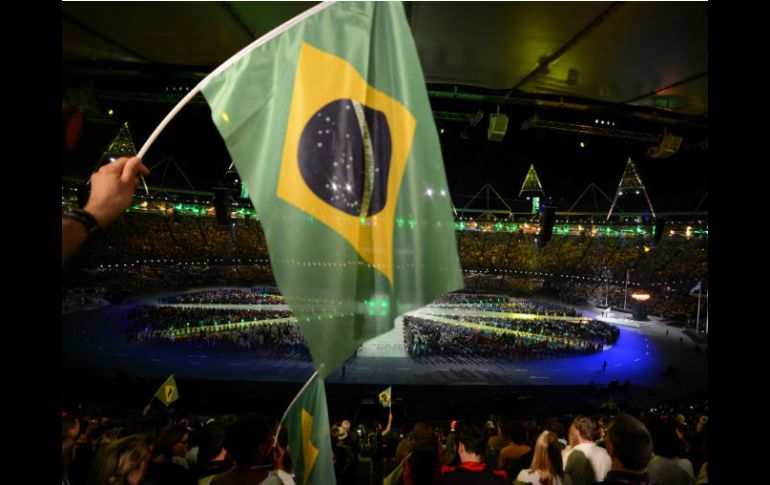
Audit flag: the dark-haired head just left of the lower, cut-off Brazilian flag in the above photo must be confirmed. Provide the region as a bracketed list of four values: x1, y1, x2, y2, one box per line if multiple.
[225, 414, 273, 469]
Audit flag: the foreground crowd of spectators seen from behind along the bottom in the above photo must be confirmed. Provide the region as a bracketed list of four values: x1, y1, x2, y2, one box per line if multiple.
[61, 392, 708, 485]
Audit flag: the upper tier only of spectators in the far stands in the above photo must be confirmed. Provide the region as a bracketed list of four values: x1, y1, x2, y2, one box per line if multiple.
[63, 211, 708, 287]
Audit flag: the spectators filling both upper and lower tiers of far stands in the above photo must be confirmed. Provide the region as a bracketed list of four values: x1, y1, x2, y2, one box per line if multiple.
[64, 210, 708, 321]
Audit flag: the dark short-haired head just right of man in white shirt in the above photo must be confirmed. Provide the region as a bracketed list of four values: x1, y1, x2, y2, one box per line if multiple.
[605, 414, 652, 472]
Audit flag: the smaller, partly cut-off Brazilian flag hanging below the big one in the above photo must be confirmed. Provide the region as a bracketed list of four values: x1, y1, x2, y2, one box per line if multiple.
[286, 376, 337, 485]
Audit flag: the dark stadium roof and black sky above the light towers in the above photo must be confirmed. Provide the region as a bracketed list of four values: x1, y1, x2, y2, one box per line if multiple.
[62, 2, 708, 210]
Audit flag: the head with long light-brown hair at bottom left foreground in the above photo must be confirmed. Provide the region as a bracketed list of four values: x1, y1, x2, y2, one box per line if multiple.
[88, 435, 150, 485]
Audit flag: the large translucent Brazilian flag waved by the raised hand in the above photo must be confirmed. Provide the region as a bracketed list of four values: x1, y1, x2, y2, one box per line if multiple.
[203, 2, 463, 377]
